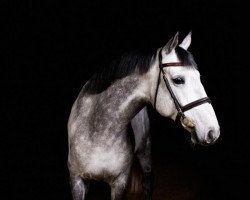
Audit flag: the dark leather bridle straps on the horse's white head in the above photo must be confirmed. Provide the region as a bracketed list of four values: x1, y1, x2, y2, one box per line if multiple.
[154, 49, 211, 120]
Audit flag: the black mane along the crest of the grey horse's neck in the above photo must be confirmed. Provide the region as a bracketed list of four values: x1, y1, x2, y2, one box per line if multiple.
[85, 51, 155, 94]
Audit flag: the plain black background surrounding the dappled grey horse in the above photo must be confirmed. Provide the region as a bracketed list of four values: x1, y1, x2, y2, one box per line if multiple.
[4, 0, 250, 199]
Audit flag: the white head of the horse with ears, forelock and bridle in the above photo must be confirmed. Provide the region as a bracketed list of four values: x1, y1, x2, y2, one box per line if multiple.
[150, 32, 220, 145]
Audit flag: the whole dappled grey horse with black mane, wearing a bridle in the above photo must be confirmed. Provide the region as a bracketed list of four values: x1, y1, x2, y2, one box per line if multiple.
[68, 33, 220, 200]
